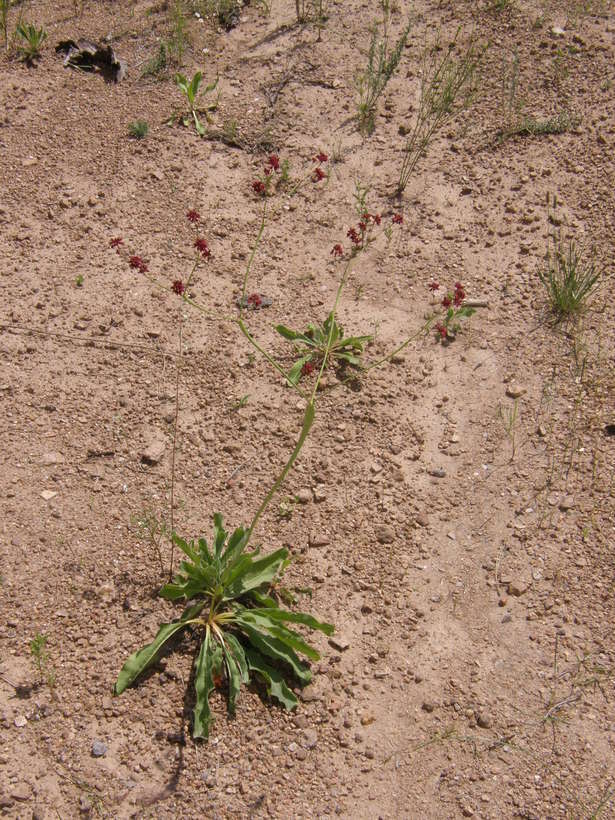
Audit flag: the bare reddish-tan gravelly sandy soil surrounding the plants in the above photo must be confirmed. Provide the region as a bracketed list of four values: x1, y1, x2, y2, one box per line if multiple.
[0, 0, 615, 820]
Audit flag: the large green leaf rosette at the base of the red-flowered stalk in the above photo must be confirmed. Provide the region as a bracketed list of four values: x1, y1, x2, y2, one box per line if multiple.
[115, 514, 333, 738]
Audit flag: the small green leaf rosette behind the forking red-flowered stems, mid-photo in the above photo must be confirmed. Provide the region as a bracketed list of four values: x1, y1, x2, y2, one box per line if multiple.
[276, 313, 373, 384]
